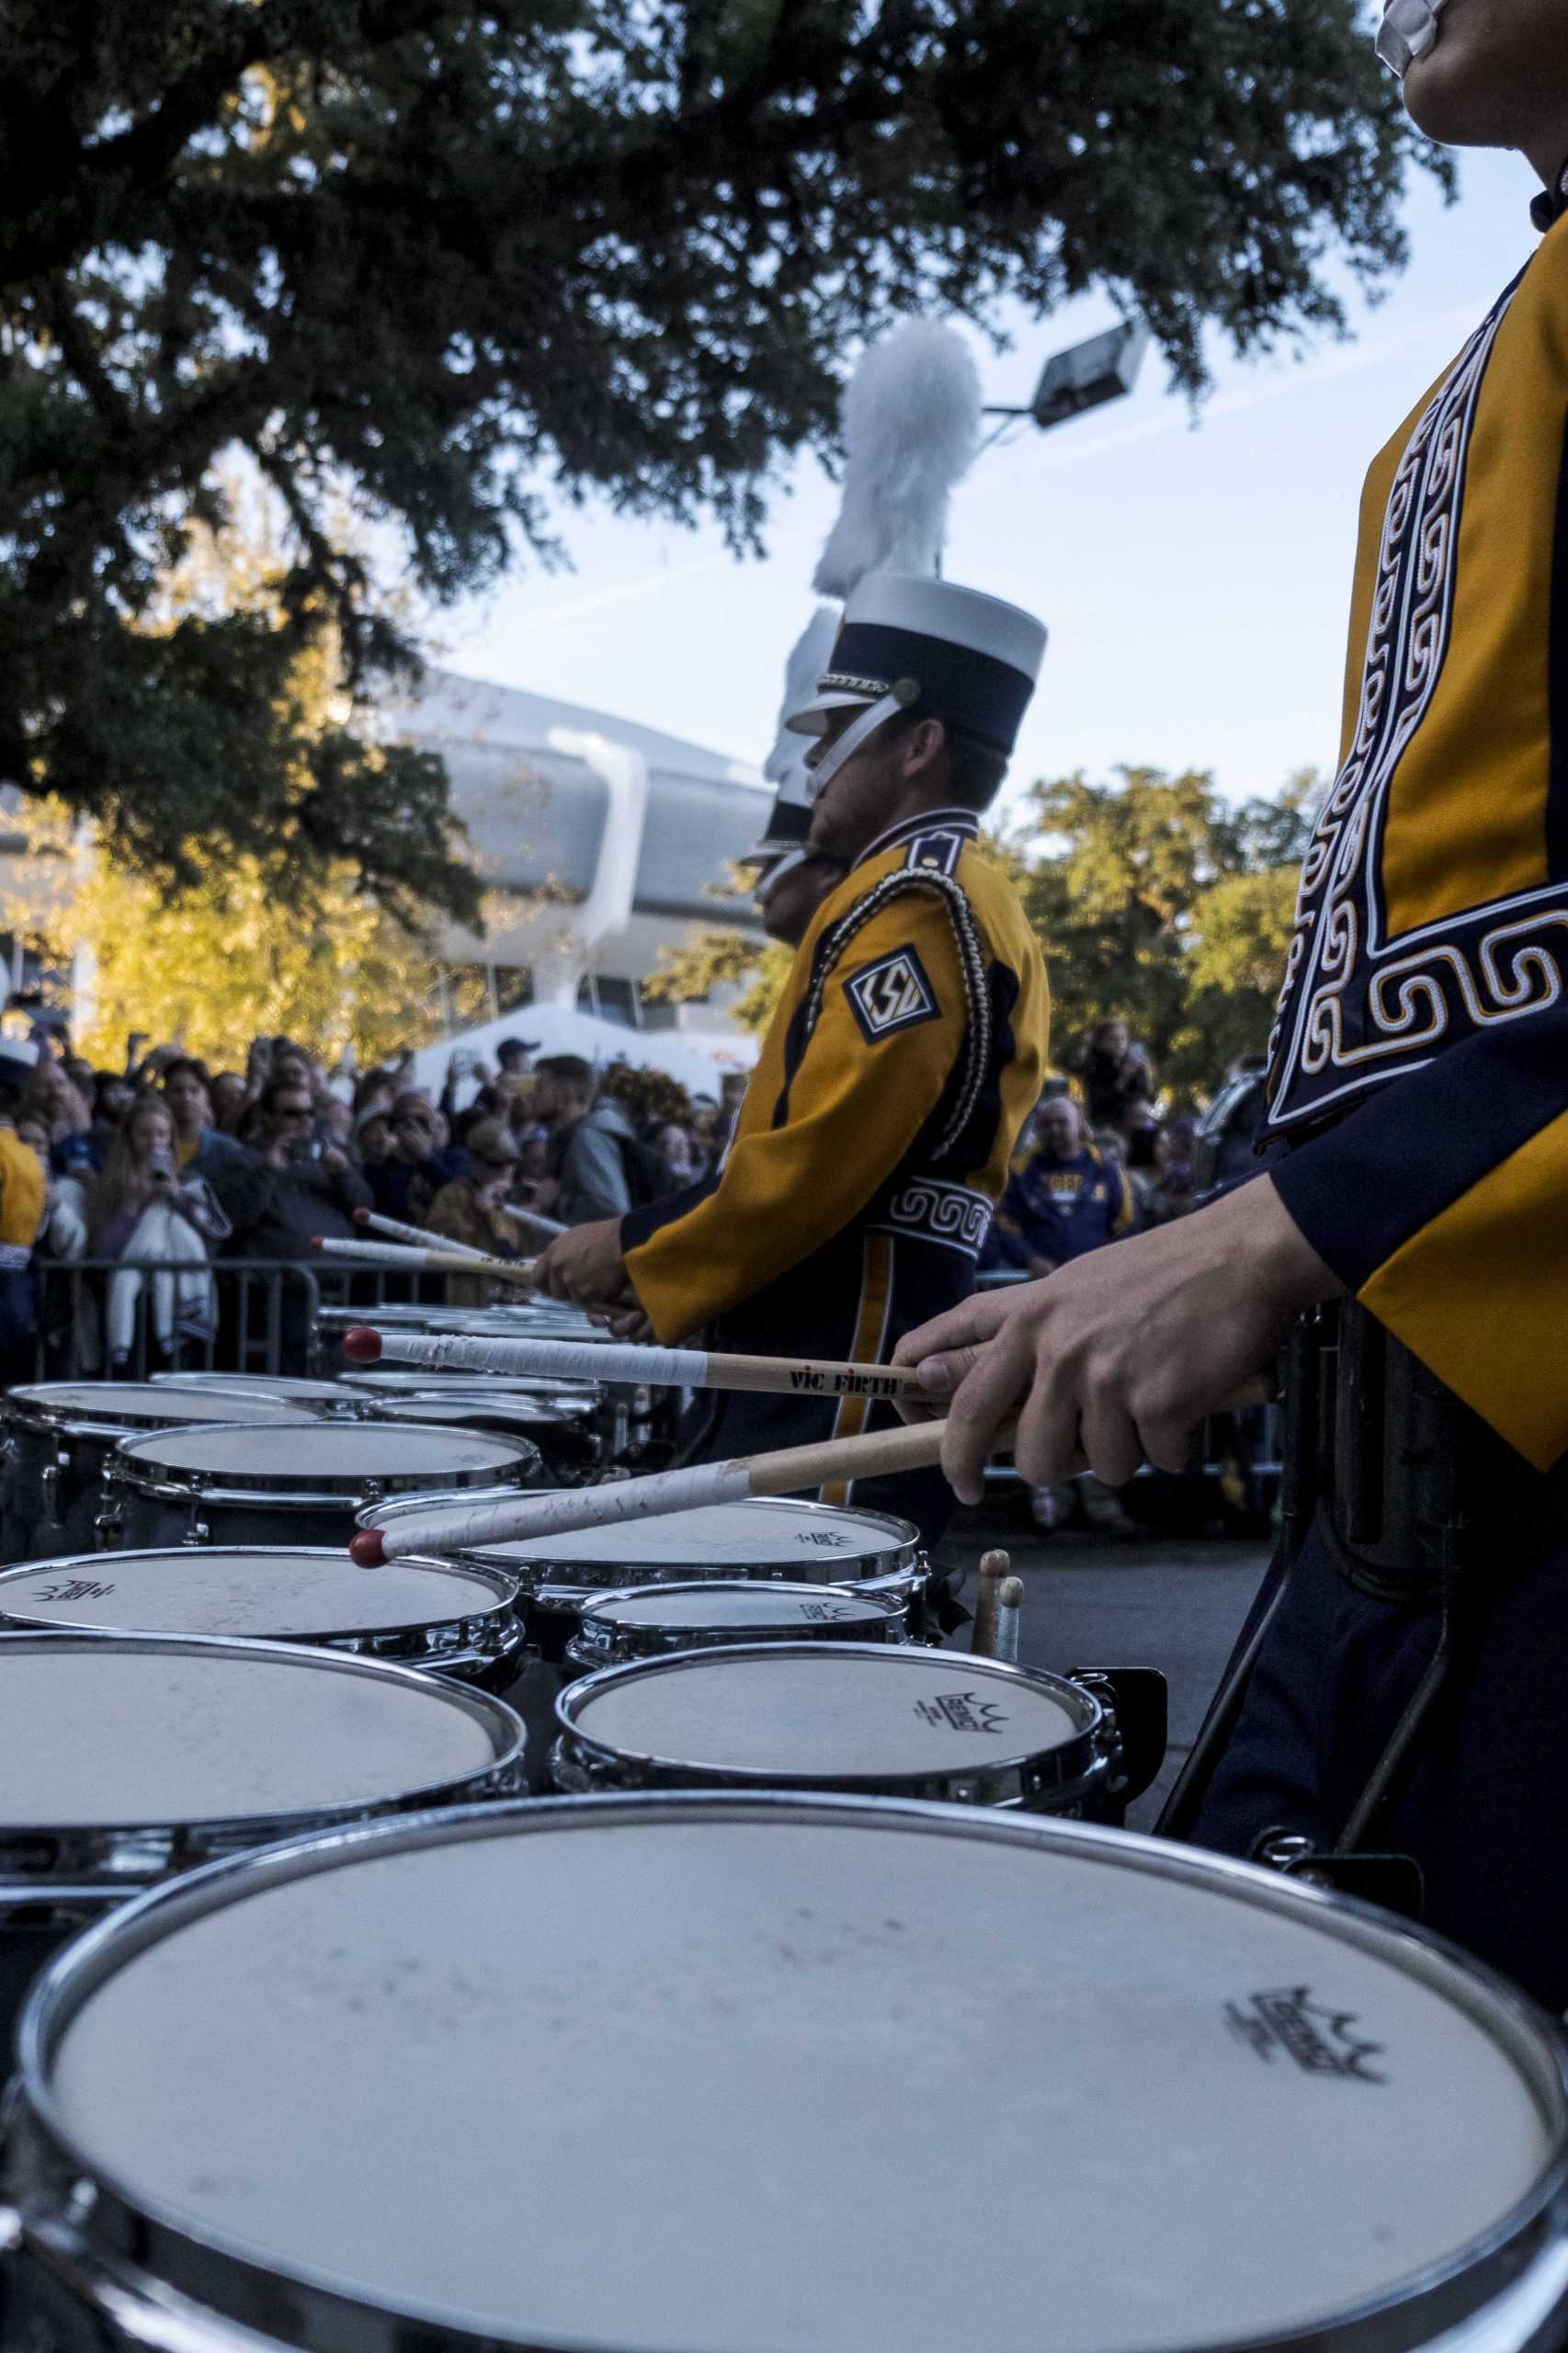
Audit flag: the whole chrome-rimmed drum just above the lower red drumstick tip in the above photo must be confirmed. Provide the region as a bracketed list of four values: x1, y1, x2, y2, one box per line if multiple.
[106, 1421, 540, 1551]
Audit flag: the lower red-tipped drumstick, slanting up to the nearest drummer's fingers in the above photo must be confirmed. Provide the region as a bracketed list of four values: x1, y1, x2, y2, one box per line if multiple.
[348, 1421, 942, 1570]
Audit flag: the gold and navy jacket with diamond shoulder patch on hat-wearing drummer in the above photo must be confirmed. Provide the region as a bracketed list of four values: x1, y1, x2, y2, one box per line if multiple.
[621, 810, 1050, 1516]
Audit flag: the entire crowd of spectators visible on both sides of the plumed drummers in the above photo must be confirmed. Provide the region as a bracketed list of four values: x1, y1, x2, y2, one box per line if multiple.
[0, 1021, 1261, 1449]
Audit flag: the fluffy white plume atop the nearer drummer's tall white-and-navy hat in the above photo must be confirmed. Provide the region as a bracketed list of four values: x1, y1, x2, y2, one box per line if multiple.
[812, 318, 980, 597]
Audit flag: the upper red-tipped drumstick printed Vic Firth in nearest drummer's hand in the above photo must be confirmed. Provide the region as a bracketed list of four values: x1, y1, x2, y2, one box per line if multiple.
[344, 1324, 926, 1400]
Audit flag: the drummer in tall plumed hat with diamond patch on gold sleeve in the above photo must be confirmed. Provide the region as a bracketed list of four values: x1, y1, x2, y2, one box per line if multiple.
[527, 572, 1048, 1541]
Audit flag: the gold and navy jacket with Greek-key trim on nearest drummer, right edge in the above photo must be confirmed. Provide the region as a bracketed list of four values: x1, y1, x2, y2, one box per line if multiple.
[1269, 222, 1568, 1468]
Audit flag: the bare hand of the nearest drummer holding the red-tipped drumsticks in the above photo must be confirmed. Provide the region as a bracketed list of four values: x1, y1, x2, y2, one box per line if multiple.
[892, 1176, 1342, 1504]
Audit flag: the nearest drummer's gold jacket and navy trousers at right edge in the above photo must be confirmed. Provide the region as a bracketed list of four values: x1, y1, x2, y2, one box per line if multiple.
[1173, 200, 1568, 2009]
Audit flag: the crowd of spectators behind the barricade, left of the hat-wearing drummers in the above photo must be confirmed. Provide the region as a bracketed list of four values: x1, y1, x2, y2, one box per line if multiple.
[0, 1038, 739, 1379]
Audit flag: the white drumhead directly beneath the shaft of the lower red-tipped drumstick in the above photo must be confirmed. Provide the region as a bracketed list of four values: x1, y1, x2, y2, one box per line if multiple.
[485, 1499, 915, 1581]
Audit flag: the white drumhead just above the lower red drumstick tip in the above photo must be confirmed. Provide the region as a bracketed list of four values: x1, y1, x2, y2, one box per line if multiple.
[125, 1412, 518, 1487]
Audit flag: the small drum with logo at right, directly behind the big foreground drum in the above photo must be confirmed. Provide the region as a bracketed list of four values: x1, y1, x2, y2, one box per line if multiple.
[551, 1643, 1119, 1819]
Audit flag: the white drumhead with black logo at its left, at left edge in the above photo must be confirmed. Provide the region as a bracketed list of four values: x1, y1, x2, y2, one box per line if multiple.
[0, 1546, 496, 1637]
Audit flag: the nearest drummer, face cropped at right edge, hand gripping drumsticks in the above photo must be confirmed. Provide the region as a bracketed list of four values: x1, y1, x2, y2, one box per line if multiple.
[900, 14, 1568, 2012]
